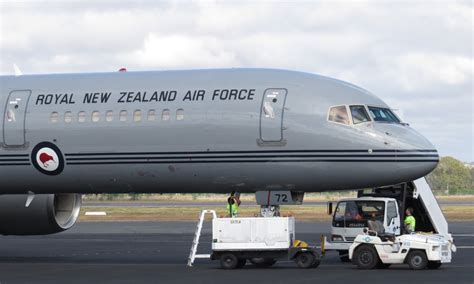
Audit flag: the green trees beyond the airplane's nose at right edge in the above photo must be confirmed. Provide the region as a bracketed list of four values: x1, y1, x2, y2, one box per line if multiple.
[427, 157, 473, 194]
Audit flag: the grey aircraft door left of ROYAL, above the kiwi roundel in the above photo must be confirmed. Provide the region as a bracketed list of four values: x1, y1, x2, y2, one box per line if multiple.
[3, 90, 31, 146]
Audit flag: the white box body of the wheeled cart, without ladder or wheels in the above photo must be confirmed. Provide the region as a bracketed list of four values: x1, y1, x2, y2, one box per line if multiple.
[212, 217, 295, 251]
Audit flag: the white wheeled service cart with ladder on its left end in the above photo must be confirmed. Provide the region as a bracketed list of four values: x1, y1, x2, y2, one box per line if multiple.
[188, 210, 321, 269]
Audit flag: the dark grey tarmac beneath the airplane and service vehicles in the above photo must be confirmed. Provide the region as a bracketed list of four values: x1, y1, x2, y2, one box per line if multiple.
[0, 220, 474, 284]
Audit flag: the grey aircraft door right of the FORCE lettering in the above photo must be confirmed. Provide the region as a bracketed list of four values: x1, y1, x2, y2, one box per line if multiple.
[260, 89, 287, 142]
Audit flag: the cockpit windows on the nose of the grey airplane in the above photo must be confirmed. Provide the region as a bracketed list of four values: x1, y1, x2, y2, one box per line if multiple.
[328, 105, 401, 125]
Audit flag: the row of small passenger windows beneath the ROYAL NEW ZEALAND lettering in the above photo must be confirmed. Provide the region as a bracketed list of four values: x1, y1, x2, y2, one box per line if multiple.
[49, 108, 184, 123]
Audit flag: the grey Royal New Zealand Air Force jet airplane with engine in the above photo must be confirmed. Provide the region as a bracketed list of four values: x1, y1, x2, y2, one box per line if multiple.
[0, 68, 439, 235]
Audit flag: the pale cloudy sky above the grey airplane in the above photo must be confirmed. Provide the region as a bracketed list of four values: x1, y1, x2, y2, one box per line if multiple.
[0, 0, 474, 162]
